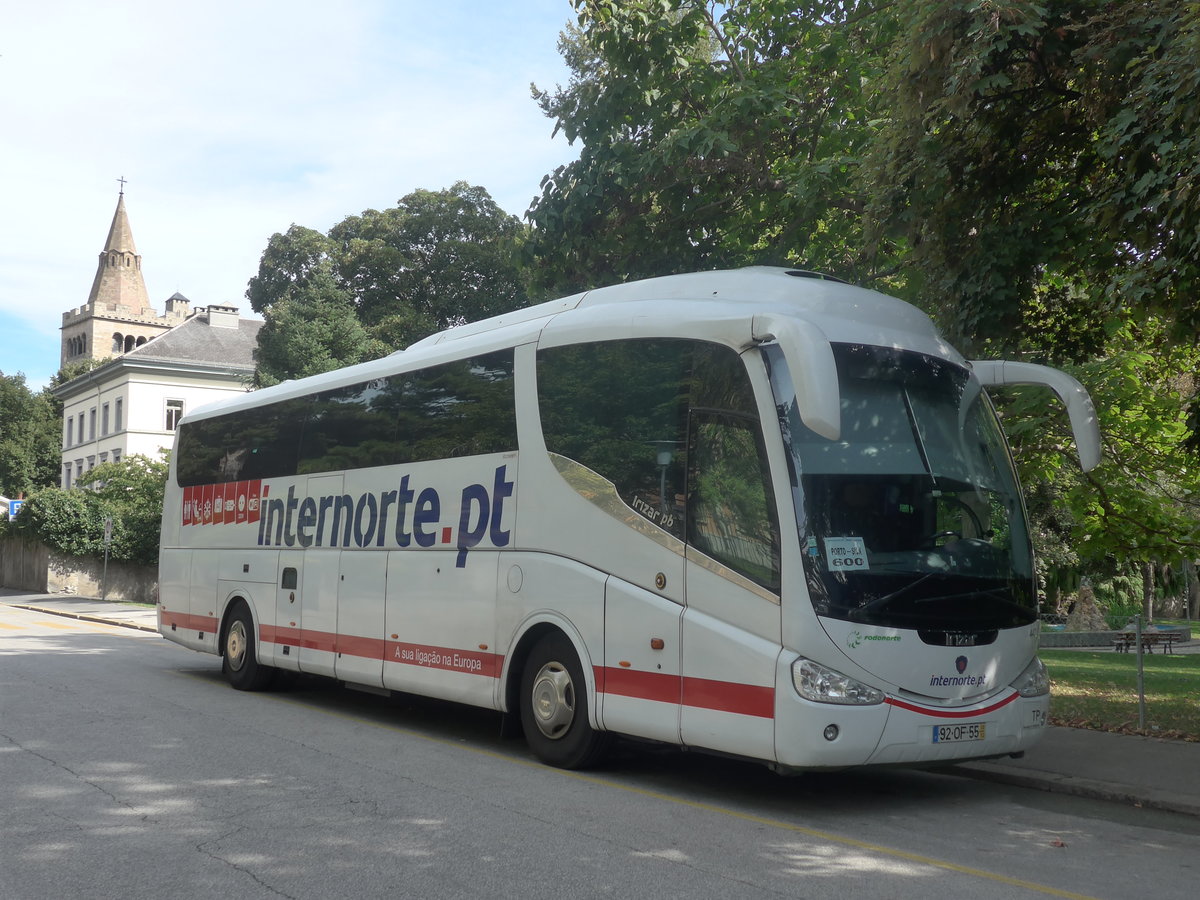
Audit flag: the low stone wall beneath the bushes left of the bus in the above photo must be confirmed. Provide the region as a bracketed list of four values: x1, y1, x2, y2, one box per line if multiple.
[0, 538, 158, 604]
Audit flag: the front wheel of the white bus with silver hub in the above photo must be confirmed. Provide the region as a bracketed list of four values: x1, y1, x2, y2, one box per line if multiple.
[521, 631, 611, 769]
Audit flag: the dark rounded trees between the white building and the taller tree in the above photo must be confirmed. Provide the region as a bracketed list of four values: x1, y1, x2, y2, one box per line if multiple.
[246, 181, 526, 386]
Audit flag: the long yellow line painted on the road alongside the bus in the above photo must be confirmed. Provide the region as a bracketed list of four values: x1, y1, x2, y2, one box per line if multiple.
[199, 672, 1097, 900]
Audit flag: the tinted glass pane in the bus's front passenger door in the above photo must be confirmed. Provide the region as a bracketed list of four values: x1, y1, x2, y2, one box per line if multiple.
[688, 412, 780, 592]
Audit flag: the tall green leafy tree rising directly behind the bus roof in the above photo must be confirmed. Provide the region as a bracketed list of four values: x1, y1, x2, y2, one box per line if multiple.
[529, 0, 898, 296]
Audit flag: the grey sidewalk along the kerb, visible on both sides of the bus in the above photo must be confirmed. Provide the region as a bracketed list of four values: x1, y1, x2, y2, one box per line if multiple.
[0, 588, 1200, 816]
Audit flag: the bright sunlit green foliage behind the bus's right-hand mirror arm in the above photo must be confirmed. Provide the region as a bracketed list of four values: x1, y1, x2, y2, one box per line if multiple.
[1002, 317, 1200, 614]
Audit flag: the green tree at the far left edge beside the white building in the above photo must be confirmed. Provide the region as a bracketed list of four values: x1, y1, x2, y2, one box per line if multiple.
[0, 373, 62, 497]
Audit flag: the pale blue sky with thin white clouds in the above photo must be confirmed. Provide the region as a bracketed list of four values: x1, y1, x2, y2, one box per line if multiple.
[0, 0, 577, 388]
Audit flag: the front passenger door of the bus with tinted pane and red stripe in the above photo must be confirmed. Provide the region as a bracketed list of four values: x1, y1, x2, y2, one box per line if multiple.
[680, 410, 781, 758]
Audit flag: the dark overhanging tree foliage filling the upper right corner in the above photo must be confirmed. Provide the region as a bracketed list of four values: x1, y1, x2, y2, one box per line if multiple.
[869, 0, 1200, 350]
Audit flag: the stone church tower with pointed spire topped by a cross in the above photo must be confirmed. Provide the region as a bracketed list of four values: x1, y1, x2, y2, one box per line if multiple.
[59, 187, 190, 366]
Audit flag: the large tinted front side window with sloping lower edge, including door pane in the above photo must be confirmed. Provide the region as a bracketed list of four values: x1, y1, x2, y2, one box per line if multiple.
[538, 338, 779, 588]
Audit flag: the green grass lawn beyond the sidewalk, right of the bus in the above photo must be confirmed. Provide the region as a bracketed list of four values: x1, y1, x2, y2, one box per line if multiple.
[1038, 648, 1200, 740]
